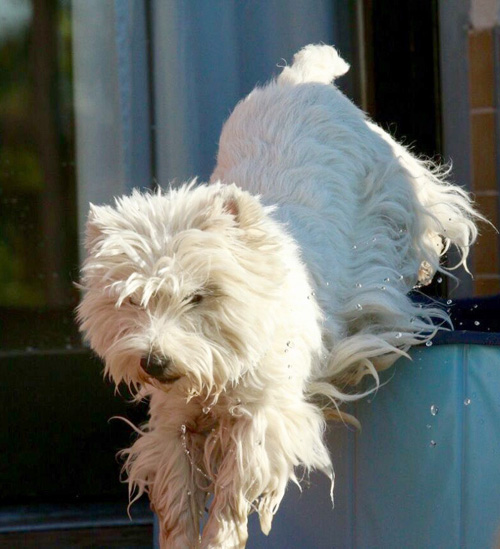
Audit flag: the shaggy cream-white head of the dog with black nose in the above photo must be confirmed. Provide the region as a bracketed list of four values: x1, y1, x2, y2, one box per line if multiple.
[78, 184, 286, 394]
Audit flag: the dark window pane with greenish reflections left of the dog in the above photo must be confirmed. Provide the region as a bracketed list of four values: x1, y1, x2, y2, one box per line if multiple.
[0, 0, 79, 350]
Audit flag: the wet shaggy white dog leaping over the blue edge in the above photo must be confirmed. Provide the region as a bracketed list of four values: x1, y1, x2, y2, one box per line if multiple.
[78, 46, 479, 548]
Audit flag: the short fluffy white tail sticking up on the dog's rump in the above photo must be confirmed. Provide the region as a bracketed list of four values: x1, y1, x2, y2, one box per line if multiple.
[278, 44, 349, 84]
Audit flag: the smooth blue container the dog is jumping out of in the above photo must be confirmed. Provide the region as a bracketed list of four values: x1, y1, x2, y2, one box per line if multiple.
[248, 332, 500, 549]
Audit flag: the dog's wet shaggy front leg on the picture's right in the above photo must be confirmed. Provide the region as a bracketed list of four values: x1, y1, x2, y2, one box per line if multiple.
[201, 398, 333, 549]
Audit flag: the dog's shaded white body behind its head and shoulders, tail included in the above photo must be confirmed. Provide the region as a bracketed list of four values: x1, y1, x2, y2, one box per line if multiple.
[212, 42, 480, 386]
